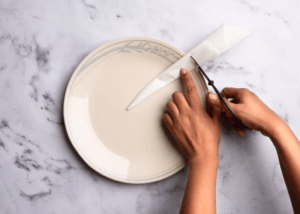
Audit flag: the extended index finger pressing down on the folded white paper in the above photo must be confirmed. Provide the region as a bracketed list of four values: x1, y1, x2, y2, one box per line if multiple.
[180, 68, 202, 108]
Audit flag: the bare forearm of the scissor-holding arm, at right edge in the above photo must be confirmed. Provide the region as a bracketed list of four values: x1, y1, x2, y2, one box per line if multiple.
[269, 118, 300, 213]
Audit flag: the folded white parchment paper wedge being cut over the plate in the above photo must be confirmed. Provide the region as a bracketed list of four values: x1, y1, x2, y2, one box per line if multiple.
[127, 24, 252, 110]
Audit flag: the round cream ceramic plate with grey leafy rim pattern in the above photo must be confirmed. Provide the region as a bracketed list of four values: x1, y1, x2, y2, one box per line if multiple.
[64, 37, 207, 183]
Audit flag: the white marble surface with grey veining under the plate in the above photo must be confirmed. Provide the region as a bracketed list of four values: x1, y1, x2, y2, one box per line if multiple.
[0, 0, 300, 214]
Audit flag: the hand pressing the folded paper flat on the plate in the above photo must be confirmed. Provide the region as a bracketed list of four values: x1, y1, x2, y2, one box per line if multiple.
[163, 68, 220, 164]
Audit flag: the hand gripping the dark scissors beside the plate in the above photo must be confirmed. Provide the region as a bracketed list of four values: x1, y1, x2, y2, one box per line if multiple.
[207, 88, 282, 136]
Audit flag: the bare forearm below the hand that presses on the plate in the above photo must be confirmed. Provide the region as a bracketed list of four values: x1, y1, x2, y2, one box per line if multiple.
[180, 160, 218, 214]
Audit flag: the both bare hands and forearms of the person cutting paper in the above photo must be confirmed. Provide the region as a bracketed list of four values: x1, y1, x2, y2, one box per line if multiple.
[163, 69, 300, 214]
